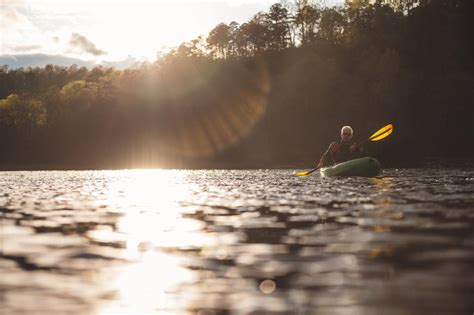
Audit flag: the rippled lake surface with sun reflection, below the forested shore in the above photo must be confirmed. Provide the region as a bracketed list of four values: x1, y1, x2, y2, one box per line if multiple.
[0, 169, 474, 315]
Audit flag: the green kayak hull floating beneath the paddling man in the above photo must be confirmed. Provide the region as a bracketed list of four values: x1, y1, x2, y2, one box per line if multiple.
[321, 157, 381, 177]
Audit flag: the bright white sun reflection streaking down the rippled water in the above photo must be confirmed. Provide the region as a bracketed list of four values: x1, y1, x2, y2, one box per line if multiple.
[89, 170, 211, 314]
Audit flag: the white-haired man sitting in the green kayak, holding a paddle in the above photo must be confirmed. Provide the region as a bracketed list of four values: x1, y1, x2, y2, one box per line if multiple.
[318, 126, 365, 167]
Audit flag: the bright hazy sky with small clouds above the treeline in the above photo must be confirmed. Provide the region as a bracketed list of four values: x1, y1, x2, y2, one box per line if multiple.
[0, 0, 340, 65]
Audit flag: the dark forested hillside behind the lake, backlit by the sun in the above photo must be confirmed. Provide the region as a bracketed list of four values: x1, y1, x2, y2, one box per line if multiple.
[0, 0, 474, 169]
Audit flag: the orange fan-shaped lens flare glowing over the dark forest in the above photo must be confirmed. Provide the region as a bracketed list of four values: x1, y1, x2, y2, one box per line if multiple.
[121, 61, 271, 167]
